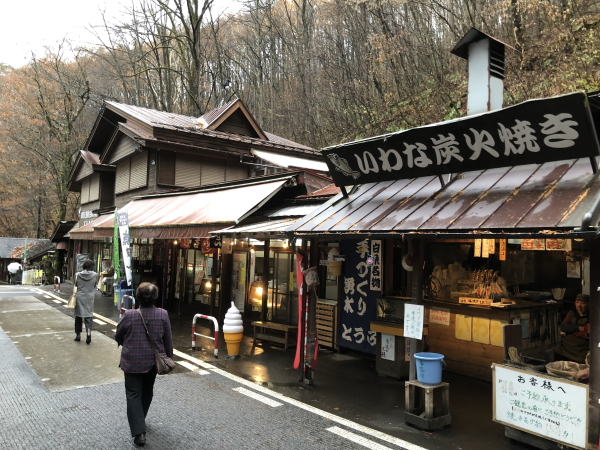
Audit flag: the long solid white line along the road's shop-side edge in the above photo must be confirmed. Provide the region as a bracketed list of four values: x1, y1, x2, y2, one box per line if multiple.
[173, 350, 427, 450]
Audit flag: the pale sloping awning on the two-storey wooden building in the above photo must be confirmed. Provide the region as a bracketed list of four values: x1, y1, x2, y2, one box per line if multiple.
[71, 177, 290, 239]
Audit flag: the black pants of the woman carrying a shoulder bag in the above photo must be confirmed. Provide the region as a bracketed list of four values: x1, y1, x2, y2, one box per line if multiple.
[125, 367, 156, 436]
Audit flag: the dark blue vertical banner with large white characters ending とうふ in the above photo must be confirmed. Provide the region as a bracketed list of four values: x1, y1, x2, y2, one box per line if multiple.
[338, 239, 381, 354]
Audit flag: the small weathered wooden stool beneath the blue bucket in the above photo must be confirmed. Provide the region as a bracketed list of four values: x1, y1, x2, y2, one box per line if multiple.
[404, 380, 451, 430]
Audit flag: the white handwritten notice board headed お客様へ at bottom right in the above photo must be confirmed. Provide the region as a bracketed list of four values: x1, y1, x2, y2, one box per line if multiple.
[492, 364, 588, 449]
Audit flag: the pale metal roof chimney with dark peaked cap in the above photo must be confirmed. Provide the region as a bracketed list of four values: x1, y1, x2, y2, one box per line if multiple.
[451, 28, 512, 116]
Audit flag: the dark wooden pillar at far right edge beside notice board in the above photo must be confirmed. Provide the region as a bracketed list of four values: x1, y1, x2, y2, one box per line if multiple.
[588, 239, 600, 448]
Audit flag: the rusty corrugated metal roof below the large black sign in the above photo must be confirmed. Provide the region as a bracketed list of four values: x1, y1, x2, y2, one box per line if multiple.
[288, 159, 600, 234]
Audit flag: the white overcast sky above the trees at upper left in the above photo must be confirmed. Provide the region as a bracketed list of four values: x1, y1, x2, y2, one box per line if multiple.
[0, 0, 239, 67]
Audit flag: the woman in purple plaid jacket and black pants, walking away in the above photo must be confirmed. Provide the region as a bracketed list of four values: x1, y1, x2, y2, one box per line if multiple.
[115, 283, 173, 446]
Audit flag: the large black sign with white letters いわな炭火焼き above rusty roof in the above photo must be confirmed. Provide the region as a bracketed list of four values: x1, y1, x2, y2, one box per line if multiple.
[323, 93, 599, 186]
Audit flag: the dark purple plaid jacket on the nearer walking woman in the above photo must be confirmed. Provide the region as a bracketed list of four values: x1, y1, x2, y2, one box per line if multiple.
[115, 306, 173, 373]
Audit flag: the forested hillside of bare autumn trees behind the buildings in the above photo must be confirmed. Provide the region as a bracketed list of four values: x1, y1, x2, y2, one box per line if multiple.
[0, 0, 600, 237]
